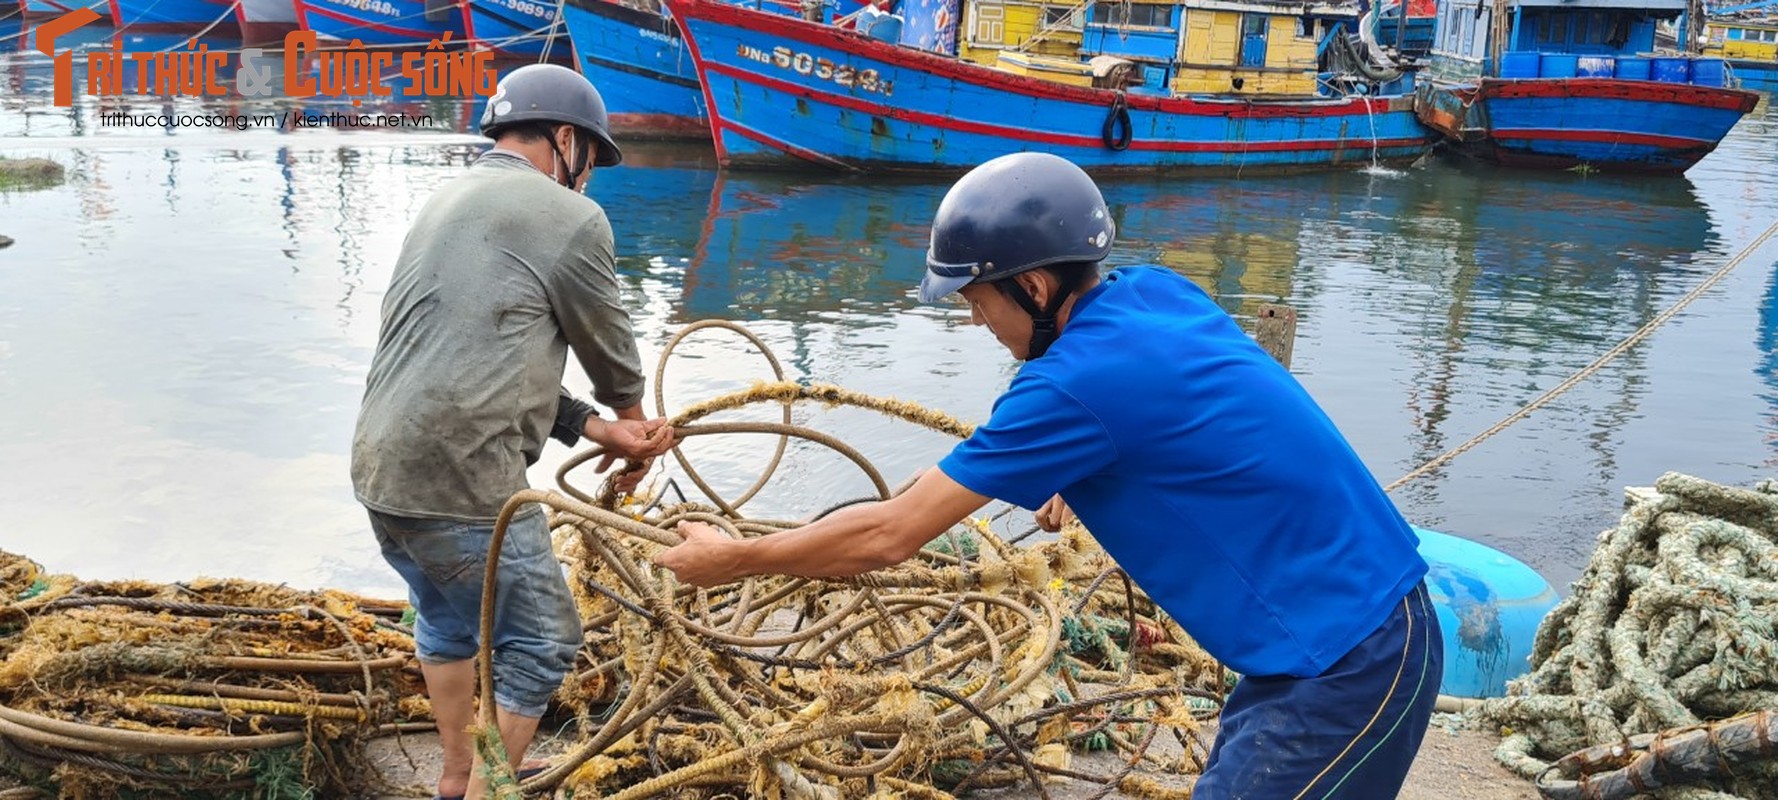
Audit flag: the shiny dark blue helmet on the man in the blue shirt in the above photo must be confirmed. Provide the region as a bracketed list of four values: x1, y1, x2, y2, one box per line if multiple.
[919, 153, 1117, 302]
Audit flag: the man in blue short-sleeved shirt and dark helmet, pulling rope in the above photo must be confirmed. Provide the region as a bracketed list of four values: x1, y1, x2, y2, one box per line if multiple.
[656, 153, 1444, 800]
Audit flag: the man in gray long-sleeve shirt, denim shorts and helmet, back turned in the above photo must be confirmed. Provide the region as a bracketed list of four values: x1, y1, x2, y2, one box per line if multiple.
[352, 64, 674, 798]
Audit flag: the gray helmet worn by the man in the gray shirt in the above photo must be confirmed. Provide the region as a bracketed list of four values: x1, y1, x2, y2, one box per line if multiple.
[482, 64, 624, 167]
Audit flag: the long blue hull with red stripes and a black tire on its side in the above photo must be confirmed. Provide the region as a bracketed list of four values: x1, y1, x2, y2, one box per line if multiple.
[669, 0, 1431, 172]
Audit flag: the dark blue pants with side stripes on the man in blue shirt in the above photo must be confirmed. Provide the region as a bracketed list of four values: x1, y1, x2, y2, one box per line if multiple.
[1191, 583, 1444, 800]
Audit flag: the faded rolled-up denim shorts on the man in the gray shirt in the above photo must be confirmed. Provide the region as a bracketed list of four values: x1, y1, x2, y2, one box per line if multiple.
[370, 510, 581, 716]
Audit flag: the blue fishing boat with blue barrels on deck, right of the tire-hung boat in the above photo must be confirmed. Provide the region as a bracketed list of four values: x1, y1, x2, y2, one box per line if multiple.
[1417, 0, 1758, 172]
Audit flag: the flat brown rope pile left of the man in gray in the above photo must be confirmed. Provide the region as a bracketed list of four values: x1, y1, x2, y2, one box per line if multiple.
[0, 553, 430, 800]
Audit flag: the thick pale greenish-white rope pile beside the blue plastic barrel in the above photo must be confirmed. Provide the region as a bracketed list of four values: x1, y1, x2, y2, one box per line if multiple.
[1479, 473, 1778, 800]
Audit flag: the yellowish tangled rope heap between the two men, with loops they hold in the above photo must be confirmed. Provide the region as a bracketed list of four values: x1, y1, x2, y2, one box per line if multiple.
[478, 322, 1227, 800]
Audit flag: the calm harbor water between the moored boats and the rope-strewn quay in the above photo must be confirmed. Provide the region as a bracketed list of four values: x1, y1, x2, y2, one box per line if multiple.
[0, 21, 1778, 596]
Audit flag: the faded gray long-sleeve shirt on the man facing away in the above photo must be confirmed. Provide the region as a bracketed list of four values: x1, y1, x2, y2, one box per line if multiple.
[352, 149, 644, 523]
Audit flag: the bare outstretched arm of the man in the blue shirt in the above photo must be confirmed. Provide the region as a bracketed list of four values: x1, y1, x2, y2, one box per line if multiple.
[654, 469, 989, 587]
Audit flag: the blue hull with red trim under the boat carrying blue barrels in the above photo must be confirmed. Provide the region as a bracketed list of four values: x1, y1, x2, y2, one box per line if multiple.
[1415, 78, 1758, 172]
